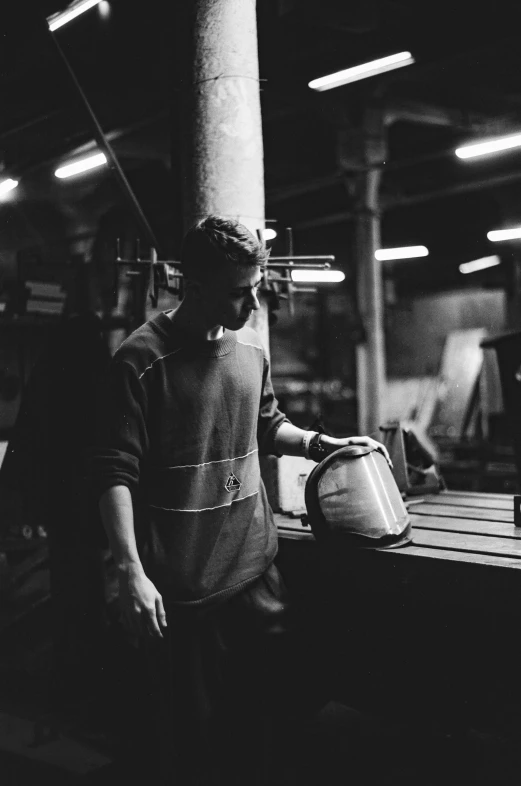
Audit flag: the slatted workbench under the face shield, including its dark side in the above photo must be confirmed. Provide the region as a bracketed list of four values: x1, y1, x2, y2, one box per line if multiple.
[275, 491, 521, 728]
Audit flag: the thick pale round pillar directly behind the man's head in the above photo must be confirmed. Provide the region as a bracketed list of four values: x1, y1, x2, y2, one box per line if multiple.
[178, 0, 269, 348]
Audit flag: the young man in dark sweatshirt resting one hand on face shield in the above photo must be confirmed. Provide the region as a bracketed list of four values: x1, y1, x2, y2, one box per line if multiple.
[95, 216, 385, 784]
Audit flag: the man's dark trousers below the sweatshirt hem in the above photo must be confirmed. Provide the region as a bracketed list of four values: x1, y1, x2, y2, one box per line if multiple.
[137, 566, 325, 786]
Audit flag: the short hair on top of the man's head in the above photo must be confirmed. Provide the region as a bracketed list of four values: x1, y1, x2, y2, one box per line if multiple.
[181, 215, 268, 278]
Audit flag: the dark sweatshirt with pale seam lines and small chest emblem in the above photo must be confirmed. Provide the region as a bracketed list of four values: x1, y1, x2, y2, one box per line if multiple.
[93, 313, 286, 604]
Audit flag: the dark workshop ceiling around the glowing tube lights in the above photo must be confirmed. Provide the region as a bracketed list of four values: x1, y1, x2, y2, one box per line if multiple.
[0, 0, 521, 285]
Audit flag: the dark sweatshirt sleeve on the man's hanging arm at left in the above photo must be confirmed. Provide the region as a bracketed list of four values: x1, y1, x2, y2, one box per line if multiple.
[91, 358, 149, 497]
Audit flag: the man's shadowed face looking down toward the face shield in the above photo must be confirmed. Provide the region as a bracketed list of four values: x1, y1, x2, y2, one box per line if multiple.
[201, 263, 262, 330]
